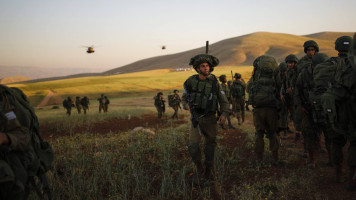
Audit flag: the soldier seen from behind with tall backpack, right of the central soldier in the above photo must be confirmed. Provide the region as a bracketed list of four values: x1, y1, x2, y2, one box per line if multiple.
[248, 55, 279, 165]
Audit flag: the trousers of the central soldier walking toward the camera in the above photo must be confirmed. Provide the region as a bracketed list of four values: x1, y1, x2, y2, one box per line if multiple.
[188, 113, 218, 166]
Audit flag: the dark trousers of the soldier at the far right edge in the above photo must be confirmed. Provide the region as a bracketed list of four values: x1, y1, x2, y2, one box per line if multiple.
[331, 132, 356, 168]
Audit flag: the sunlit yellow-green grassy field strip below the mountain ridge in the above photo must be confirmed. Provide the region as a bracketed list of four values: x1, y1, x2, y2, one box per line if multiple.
[9, 66, 252, 105]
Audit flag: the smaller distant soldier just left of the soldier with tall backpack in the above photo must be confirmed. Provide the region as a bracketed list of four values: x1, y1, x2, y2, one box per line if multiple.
[231, 73, 246, 125]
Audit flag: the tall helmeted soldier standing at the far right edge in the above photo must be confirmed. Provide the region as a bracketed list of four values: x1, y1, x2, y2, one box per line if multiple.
[320, 36, 356, 186]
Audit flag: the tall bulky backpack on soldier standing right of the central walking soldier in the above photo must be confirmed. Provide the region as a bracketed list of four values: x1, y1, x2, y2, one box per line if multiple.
[249, 55, 278, 108]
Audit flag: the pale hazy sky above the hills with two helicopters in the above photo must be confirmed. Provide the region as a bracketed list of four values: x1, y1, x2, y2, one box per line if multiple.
[0, 0, 356, 71]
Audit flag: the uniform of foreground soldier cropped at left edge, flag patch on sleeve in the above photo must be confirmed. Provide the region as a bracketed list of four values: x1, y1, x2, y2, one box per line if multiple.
[0, 85, 31, 200]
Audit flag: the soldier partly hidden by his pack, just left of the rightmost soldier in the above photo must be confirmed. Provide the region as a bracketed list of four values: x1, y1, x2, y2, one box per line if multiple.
[296, 53, 331, 168]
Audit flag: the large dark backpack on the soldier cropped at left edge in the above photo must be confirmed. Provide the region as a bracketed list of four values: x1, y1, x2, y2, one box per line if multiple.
[0, 85, 54, 199]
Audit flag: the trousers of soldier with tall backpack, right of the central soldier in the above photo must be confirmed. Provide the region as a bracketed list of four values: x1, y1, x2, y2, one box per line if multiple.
[253, 107, 279, 153]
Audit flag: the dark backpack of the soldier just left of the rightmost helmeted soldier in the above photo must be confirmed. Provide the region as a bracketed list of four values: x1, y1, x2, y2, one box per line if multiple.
[309, 57, 346, 123]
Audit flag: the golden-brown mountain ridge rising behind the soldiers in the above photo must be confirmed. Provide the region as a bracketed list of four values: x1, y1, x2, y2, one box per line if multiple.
[4, 32, 354, 82]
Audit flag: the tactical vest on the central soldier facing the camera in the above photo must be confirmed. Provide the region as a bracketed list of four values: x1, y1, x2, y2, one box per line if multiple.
[188, 75, 219, 114]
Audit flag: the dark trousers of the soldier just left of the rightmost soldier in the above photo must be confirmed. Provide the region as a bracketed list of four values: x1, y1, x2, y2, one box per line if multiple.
[302, 116, 333, 152]
